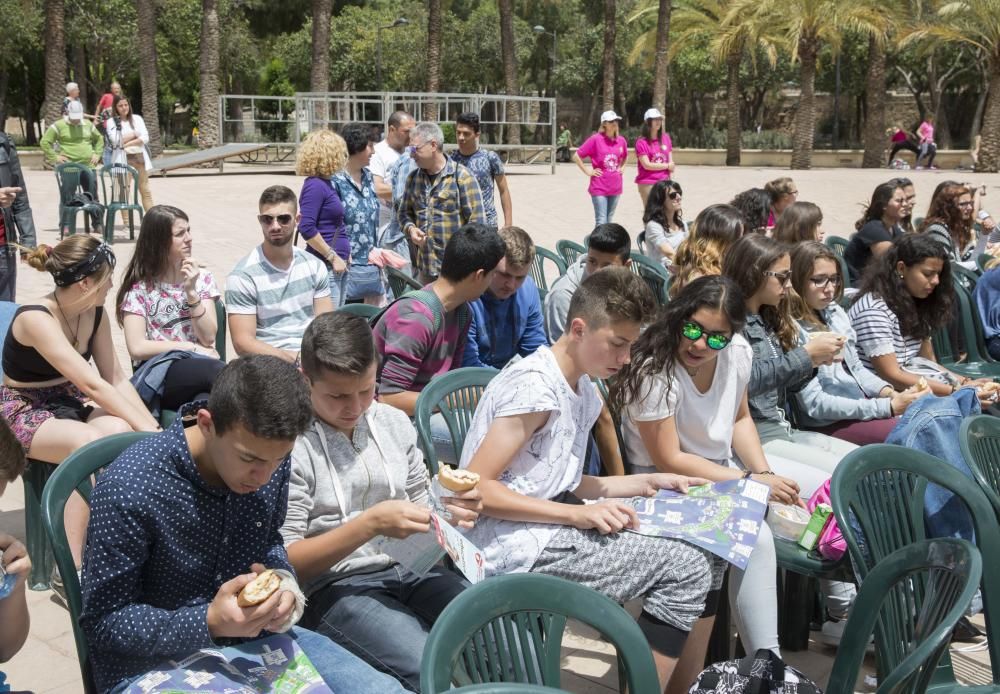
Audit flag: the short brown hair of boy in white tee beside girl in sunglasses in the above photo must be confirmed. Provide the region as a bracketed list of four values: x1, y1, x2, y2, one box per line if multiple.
[566, 267, 656, 328]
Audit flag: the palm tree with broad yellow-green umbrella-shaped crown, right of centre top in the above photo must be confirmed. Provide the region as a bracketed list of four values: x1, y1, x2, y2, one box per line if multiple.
[724, 0, 887, 169]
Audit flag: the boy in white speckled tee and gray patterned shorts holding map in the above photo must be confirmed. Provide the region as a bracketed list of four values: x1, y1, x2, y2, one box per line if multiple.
[462, 269, 724, 691]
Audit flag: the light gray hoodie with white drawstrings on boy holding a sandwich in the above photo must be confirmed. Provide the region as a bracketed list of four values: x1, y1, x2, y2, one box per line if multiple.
[281, 402, 429, 595]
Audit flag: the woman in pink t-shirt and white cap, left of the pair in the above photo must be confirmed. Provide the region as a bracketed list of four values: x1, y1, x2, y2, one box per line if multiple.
[573, 111, 628, 226]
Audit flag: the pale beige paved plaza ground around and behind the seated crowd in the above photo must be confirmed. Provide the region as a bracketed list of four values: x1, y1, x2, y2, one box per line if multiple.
[0, 164, 1000, 693]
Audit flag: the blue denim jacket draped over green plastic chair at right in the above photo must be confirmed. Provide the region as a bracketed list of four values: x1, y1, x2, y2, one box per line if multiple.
[885, 388, 981, 541]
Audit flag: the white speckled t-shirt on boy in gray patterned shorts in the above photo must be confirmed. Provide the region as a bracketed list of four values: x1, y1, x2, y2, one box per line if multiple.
[460, 347, 601, 576]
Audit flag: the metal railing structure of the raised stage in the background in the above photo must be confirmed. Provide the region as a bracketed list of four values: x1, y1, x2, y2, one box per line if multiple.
[219, 92, 557, 173]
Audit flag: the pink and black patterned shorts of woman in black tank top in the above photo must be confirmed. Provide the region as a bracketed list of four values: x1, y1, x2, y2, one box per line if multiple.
[0, 382, 94, 453]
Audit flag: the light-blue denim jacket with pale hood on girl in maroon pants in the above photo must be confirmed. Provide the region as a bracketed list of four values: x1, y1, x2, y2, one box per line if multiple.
[792, 303, 892, 428]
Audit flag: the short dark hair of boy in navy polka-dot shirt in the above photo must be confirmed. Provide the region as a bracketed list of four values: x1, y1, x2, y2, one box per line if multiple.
[208, 354, 313, 441]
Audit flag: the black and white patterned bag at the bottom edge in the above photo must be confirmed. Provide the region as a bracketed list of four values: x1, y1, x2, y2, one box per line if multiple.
[688, 648, 823, 694]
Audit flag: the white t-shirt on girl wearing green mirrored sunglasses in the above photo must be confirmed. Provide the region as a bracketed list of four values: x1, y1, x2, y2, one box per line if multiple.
[622, 335, 753, 472]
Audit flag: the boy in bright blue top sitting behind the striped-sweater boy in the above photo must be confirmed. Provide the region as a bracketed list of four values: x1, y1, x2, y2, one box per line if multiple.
[462, 227, 548, 369]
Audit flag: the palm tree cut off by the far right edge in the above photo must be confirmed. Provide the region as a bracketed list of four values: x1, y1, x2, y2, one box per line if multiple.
[902, 0, 1000, 172]
